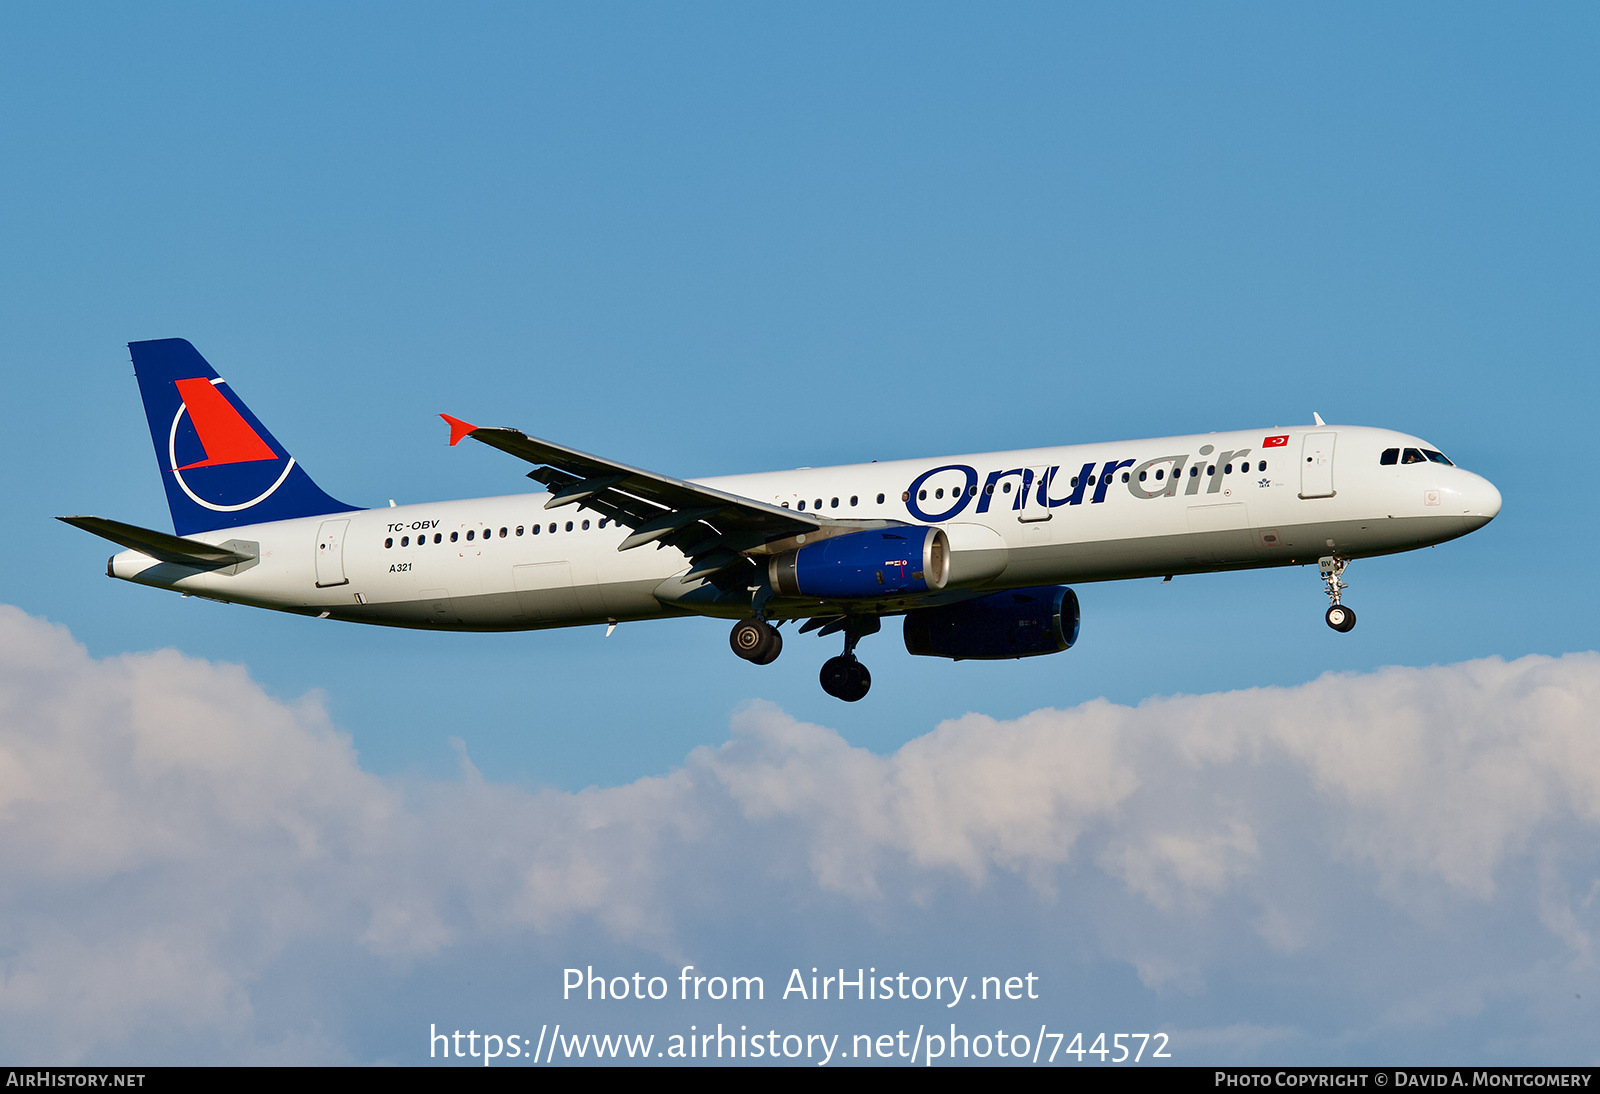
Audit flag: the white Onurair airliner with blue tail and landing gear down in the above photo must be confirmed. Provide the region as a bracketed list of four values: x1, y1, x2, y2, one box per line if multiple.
[59, 339, 1501, 702]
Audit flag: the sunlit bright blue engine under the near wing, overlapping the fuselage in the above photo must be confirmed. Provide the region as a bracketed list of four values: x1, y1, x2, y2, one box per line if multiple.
[766, 526, 950, 600]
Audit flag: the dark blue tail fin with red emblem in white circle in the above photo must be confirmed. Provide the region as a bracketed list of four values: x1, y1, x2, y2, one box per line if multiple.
[128, 337, 358, 536]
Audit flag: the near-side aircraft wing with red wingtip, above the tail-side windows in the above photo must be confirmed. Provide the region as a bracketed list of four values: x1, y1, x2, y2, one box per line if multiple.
[440, 414, 885, 585]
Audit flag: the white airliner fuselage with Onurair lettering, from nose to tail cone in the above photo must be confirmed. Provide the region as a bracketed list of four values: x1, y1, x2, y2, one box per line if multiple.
[109, 425, 1501, 630]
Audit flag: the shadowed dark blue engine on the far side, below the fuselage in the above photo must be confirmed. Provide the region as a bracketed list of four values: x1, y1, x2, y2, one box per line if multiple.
[906, 585, 1078, 661]
